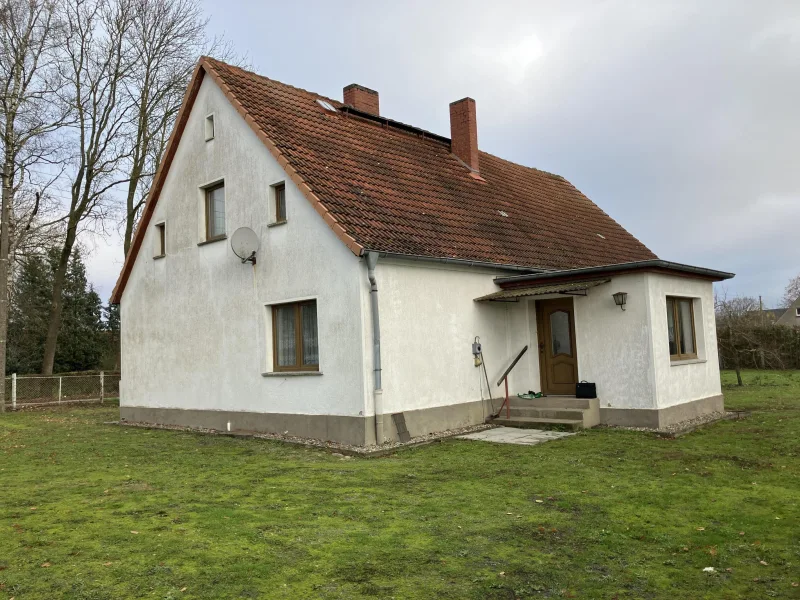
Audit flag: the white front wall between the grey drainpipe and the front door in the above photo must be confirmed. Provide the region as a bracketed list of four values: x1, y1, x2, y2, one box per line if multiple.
[374, 259, 539, 414]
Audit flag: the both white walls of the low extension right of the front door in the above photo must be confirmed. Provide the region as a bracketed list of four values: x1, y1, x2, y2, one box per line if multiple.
[575, 273, 722, 409]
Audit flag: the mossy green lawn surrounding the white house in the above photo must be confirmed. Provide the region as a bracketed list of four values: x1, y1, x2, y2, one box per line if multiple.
[0, 372, 800, 600]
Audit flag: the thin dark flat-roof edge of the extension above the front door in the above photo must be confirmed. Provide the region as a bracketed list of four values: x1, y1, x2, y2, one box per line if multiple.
[495, 260, 734, 288]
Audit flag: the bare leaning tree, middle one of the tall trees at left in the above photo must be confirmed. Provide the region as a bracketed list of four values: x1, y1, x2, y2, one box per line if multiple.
[42, 0, 135, 375]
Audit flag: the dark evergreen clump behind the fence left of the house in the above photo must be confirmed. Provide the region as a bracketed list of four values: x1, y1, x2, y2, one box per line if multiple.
[7, 250, 104, 373]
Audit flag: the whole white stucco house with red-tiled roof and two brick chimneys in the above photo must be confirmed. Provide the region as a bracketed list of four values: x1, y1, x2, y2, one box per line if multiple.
[112, 58, 732, 445]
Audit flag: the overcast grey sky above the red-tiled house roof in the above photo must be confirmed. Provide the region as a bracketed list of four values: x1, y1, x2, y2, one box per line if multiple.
[90, 0, 800, 306]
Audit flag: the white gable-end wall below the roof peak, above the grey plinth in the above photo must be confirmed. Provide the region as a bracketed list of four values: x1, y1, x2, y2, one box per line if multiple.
[120, 77, 366, 416]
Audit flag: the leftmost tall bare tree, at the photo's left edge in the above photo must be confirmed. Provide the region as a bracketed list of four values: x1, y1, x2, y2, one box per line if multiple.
[0, 0, 65, 404]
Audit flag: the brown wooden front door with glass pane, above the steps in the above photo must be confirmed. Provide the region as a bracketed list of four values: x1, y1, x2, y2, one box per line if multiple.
[536, 298, 578, 396]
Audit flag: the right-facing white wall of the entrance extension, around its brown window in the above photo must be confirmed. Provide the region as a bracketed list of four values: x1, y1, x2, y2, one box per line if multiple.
[647, 273, 722, 408]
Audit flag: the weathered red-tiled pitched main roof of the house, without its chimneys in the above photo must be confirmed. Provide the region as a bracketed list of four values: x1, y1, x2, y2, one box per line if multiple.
[112, 58, 657, 302]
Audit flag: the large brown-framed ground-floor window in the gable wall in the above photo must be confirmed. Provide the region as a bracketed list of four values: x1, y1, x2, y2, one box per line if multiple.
[272, 300, 319, 371]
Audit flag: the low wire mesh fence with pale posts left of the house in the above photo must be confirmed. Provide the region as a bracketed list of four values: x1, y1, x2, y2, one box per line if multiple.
[5, 371, 119, 410]
